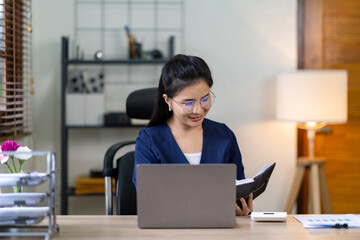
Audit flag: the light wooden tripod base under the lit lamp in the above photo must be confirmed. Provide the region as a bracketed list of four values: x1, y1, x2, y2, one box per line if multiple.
[285, 157, 332, 214]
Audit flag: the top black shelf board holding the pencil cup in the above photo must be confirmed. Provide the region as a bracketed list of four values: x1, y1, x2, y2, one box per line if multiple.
[65, 58, 168, 65]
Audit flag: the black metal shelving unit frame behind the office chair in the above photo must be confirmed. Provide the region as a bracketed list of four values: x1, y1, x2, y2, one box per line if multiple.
[61, 37, 174, 215]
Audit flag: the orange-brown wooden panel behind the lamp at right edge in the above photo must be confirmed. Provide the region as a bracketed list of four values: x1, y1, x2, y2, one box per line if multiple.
[298, 0, 360, 214]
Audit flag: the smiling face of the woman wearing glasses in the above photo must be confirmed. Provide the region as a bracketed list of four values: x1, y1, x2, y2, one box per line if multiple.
[163, 79, 211, 128]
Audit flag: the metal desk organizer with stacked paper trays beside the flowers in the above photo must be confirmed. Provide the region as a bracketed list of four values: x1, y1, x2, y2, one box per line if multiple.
[0, 152, 59, 240]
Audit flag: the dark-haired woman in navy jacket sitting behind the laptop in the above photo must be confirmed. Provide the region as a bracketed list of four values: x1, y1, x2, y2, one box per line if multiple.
[133, 55, 253, 215]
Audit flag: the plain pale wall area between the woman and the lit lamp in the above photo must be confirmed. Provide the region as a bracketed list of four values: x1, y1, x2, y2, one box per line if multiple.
[185, 0, 296, 211]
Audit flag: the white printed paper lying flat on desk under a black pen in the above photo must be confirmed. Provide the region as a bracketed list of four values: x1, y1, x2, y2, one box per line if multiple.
[294, 214, 360, 228]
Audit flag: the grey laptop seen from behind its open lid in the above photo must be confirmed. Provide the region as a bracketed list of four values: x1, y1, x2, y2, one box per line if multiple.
[136, 164, 236, 228]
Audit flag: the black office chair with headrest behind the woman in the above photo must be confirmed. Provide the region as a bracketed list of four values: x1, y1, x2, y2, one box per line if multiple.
[103, 88, 157, 215]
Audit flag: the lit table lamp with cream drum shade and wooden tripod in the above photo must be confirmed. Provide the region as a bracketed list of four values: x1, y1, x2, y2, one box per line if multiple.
[276, 70, 347, 213]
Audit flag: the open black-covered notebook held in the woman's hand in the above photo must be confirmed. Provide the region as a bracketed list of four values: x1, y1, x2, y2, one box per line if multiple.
[236, 163, 276, 207]
